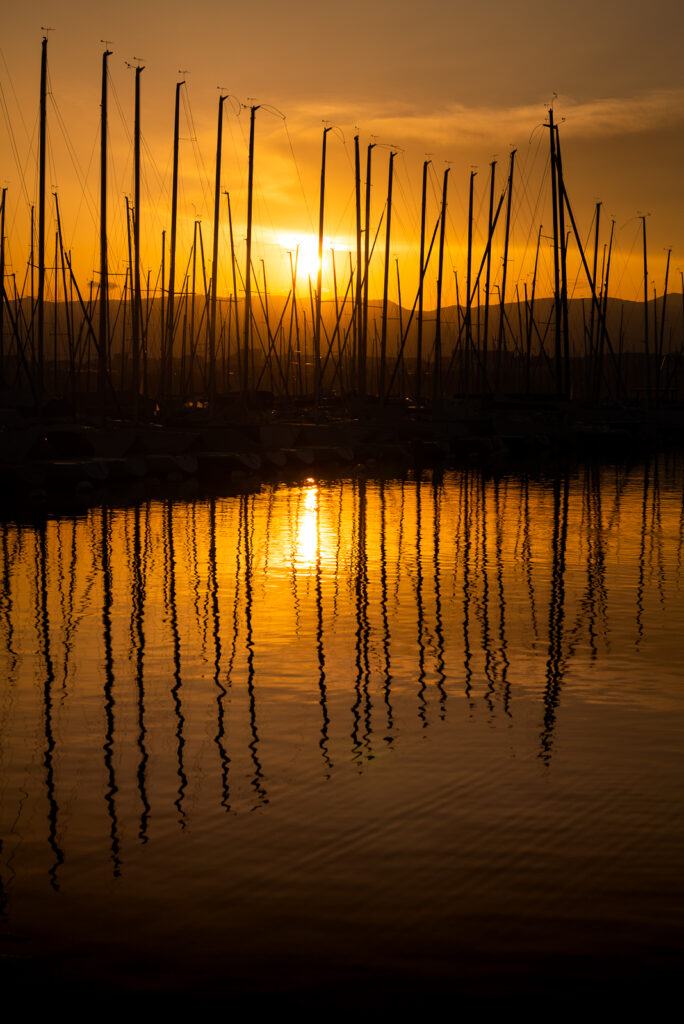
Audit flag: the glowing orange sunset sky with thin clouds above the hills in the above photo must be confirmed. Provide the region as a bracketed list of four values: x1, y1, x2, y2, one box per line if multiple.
[0, 0, 684, 305]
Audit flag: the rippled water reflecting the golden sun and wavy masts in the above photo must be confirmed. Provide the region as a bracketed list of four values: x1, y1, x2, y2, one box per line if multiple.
[0, 458, 684, 1015]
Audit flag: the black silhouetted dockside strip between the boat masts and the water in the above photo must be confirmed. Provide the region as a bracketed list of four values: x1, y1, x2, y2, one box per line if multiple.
[0, 396, 684, 514]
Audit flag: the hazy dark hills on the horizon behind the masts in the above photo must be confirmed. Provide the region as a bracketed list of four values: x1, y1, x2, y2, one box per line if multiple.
[3, 293, 684, 358]
